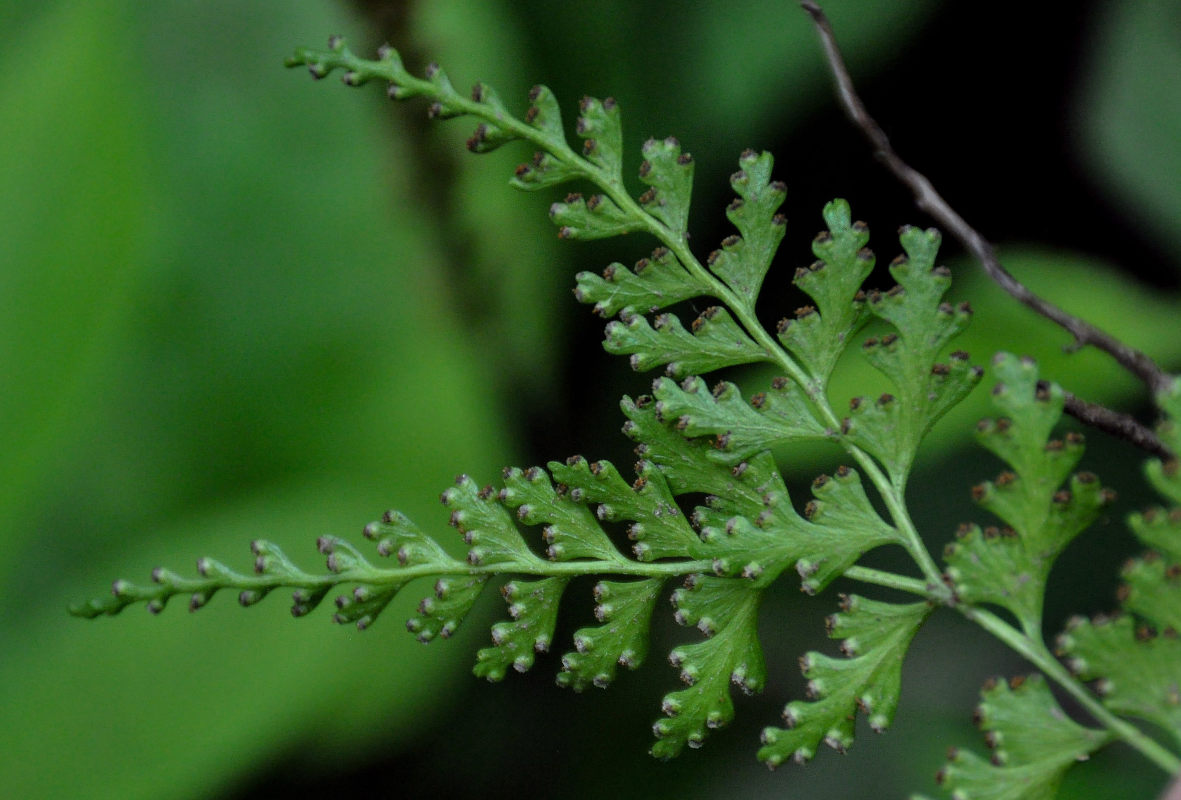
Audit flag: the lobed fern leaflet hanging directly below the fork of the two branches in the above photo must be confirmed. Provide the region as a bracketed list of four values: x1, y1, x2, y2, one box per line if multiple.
[758, 594, 932, 767]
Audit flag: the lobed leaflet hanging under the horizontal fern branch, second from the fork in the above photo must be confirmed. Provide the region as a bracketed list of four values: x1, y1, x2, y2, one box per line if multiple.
[652, 575, 766, 759]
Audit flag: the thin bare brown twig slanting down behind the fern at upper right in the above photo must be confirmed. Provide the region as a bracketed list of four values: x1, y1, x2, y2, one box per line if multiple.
[800, 0, 1172, 457]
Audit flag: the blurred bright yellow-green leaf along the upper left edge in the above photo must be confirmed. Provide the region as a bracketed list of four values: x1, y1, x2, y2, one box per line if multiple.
[0, 4, 158, 571]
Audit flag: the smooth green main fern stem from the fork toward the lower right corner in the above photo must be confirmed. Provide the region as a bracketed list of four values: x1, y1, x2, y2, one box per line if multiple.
[957, 605, 1181, 775]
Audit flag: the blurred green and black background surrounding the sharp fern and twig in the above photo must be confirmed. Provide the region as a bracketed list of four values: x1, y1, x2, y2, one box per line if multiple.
[0, 0, 1181, 799]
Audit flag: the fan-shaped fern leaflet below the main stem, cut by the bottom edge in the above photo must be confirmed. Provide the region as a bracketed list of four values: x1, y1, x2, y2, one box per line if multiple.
[938, 675, 1111, 800]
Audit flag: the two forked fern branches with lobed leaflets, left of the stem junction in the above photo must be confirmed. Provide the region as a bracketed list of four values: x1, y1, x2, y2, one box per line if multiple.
[77, 38, 1015, 763]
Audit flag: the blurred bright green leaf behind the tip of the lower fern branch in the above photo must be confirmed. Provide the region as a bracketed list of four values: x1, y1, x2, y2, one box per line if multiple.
[0, 474, 478, 799]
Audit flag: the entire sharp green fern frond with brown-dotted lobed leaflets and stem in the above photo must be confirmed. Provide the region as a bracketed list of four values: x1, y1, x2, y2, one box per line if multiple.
[72, 38, 1181, 798]
